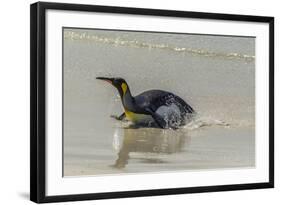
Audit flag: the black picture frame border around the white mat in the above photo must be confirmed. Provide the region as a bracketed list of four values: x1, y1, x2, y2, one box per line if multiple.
[30, 2, 274, 203]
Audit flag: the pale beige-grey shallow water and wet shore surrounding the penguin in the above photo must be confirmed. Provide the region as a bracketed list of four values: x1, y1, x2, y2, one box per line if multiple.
[64, 29, 255, 176]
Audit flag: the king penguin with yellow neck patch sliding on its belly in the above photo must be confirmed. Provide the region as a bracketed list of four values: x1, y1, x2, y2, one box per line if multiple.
[96, 77, 195, 129]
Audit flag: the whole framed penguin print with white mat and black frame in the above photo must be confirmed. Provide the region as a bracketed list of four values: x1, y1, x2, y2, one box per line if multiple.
[30, 2, 274, 203]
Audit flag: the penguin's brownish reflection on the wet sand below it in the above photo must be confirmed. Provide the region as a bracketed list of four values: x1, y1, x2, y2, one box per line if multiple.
[113, 127, 190, 168]
